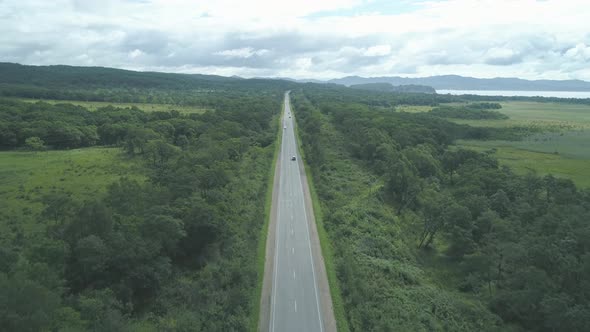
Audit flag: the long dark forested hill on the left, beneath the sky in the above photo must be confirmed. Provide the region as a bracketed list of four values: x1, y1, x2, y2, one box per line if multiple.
[0, 63, 294, 105]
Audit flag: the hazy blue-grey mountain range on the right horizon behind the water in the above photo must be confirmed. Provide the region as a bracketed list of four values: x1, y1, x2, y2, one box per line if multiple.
[327, 75, 590, 91]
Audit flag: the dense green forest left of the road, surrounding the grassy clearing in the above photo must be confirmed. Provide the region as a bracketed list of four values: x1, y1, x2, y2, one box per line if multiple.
[0, 74, 284, 331]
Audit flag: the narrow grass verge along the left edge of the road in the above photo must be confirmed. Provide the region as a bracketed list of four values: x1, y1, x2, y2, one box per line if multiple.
[250, 103, 285, 332]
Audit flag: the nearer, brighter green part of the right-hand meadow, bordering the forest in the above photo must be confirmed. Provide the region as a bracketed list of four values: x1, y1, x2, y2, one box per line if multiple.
[456, 139, 590, 188]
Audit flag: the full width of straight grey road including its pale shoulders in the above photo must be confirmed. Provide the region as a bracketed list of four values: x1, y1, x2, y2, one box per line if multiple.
[260, 93, 335, 332]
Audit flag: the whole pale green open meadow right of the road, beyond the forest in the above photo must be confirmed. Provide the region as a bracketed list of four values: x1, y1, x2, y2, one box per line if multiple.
[452, 102, 590, 188]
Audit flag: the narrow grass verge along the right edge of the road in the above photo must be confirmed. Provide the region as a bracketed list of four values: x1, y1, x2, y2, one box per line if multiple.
[291, 106, 350, 332]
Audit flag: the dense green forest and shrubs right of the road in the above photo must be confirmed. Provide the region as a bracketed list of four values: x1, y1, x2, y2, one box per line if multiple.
[292, 85, 590, 331]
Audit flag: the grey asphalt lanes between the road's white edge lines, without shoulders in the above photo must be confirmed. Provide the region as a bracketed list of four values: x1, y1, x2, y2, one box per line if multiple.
[269, 94, 324, 332]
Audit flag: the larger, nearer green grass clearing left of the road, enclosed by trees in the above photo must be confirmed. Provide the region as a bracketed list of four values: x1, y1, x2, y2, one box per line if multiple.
[0, 148, 143, 234]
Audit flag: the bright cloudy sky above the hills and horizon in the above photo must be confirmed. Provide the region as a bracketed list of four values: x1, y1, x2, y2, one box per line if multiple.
[0, 0, 590, 81]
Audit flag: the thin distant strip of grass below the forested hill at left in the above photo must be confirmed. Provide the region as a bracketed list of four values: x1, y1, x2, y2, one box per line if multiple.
[18, 98, 208, 114]
